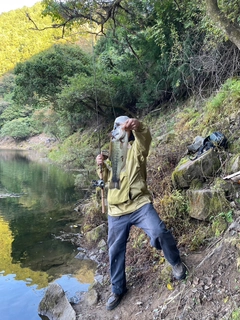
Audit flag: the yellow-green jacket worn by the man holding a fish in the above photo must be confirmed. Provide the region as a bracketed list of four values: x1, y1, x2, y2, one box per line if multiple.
[98, 123, 152, 216]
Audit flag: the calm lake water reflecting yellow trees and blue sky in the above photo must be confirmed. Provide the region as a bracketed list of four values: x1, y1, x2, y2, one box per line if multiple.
[0, 150, 95, 320]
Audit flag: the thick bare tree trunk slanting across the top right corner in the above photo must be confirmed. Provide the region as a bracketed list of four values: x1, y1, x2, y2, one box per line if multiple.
[206, 0, 240, 50]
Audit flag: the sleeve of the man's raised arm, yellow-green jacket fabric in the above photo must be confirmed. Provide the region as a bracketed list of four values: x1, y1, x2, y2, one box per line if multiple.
[133, 122, 152, 157]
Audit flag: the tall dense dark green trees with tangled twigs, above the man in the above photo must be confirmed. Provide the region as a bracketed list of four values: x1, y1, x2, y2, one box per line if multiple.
[39, 0, 240, 111]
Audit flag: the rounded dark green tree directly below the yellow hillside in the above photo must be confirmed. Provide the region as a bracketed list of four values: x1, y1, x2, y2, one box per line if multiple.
[13, 45, 91, 106]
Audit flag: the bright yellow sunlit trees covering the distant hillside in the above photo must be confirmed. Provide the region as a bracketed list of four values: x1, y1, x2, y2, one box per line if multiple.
[0, 3, 61, 75]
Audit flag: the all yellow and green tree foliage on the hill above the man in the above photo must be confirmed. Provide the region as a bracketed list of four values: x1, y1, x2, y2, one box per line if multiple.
[0, 0, 240, 151]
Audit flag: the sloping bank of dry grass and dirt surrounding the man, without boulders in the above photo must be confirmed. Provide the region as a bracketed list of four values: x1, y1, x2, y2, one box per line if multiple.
[65, 92, 240, 320]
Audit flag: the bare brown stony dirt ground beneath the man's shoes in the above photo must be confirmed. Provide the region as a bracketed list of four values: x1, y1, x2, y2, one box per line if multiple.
[74, 212, 240, 320]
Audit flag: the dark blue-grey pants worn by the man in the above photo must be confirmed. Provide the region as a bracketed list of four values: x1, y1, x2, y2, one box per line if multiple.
[108, 204, 180, 294]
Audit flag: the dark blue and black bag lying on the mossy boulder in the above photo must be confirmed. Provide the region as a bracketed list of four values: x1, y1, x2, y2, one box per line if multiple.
[190, 131, 228, 160]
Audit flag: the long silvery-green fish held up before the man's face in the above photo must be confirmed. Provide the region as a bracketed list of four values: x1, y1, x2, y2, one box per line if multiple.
[109, 126, 128, 189]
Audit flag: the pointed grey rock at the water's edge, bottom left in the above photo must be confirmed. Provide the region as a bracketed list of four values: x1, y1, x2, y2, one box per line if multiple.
[38, 283, 76, 320]
